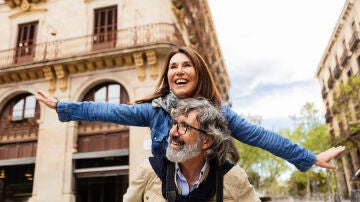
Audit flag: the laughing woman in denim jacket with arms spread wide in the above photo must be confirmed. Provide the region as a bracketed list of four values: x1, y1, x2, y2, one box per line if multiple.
[37, 47, 345, 171]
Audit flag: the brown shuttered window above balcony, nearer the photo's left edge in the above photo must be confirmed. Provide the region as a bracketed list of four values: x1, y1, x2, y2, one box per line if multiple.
[15, 22, 38, 63]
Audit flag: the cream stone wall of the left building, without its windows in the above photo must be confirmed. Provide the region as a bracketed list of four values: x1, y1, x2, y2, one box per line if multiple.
[0, 0, 230, 202]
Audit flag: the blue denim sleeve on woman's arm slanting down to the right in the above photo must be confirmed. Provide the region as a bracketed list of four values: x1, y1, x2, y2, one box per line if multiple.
[222, 105, 316, 172]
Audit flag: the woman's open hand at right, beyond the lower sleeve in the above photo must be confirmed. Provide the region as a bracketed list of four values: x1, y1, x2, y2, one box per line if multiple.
[315, 146, 345, 169]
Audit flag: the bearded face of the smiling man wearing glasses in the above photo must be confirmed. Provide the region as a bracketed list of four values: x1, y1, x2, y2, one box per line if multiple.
[166, 110, 202, 162]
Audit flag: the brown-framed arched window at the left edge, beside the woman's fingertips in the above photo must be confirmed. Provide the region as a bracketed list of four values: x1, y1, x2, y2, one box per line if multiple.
[0, 93, 40, 160]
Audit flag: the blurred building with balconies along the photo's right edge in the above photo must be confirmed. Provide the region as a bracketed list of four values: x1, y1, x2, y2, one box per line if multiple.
[316, 0, 360, 199]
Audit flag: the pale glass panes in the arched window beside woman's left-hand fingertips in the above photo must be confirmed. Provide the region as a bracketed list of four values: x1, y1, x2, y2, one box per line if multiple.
[11, 95, 36, 121]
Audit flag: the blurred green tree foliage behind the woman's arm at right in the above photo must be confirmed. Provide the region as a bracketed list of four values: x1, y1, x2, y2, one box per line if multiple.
[234, 103, 330, 196]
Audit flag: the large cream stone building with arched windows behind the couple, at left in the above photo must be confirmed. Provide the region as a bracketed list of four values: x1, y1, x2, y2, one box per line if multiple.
[0, 0, 230, 202]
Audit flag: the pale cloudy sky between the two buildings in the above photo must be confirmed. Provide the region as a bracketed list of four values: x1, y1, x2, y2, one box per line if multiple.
[208, 0, 345, 130]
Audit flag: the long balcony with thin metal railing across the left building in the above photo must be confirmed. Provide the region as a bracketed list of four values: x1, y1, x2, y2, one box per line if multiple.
[0, 23, 184, 70]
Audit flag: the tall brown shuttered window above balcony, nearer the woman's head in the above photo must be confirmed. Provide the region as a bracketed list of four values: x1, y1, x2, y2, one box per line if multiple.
[93, 6, 117, 50]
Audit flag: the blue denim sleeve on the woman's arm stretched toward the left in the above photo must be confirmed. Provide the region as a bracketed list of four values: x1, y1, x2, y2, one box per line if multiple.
[56, 101, 153, 126]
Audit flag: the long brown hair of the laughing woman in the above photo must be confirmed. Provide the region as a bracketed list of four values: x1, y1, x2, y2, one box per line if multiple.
[136, 47, 221, 107]
